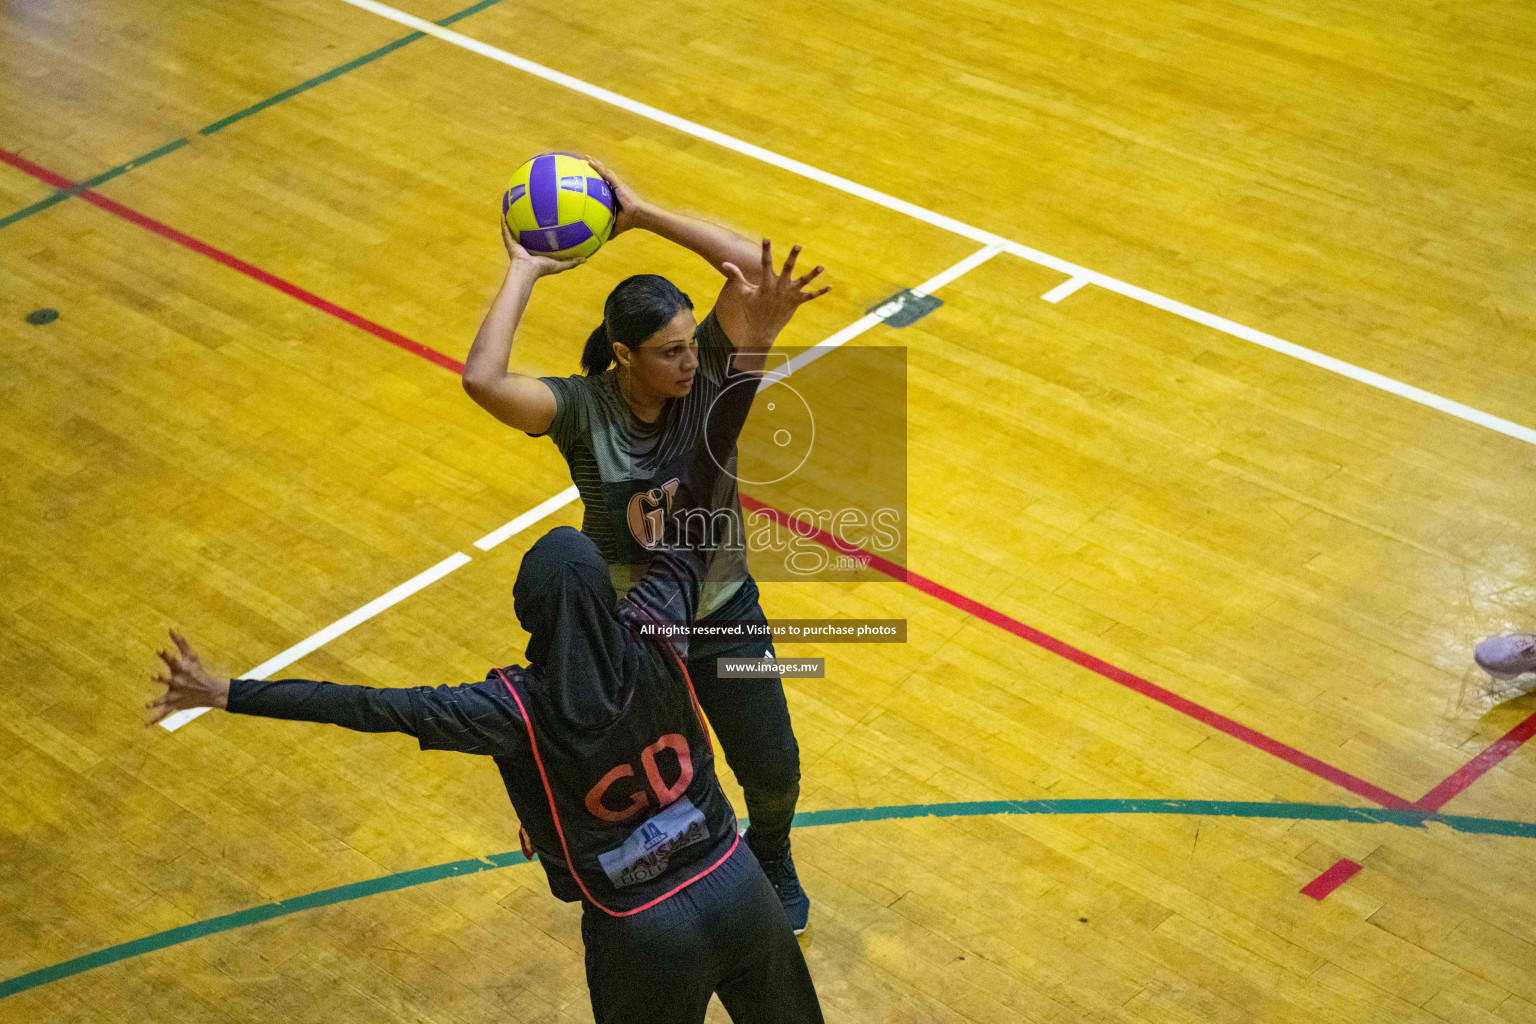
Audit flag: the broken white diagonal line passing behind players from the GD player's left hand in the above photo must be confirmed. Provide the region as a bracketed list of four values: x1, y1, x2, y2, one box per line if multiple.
[160, 246, 1001, 732]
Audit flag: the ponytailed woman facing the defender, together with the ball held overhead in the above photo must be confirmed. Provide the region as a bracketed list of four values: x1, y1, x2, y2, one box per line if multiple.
[464, 154, 828, 933]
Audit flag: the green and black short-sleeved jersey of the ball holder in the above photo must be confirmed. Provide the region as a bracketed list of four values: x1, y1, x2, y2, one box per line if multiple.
[539, 312, 746, 619]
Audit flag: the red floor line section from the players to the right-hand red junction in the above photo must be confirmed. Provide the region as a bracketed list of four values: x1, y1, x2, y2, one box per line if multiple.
[742, 494, 1410, 811]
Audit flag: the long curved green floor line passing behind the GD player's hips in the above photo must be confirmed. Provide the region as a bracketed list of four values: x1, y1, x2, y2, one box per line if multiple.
[0, 800, 1536, 999]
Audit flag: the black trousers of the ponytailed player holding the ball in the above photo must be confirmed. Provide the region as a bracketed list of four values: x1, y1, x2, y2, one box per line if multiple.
[688, 589, 800, 860]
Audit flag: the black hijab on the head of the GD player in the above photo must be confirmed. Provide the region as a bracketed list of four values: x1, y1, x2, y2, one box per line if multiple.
[511, 527, 644, 729]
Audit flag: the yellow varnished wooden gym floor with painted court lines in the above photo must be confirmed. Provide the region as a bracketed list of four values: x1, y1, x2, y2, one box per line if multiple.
[0, 0, 1536, 1024]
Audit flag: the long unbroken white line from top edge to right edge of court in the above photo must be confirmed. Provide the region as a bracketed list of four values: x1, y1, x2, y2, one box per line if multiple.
[333, 0, 1536, 444]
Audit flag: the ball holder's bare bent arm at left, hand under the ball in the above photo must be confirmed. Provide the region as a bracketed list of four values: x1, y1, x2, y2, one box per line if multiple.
[464, 218, 584, 434]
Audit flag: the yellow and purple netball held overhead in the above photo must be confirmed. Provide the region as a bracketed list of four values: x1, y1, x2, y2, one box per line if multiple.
[501, 154, 614, 259]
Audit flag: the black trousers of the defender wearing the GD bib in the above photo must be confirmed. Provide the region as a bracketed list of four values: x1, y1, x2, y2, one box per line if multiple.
[581, 843, 822, 1024]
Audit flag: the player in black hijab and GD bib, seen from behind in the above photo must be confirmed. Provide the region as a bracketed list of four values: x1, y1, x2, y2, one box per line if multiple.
[149, 346, 822, 1024]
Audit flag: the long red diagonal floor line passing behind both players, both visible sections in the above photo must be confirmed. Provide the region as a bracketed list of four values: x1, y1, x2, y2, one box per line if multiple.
[0, 140, 1410, 811]
